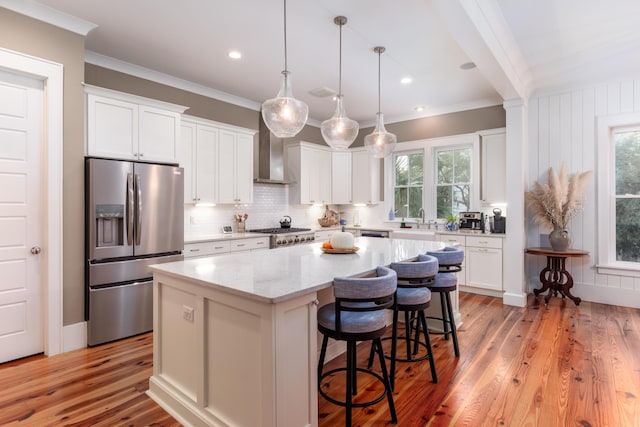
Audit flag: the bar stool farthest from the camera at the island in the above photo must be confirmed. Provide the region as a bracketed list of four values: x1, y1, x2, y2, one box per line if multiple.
[418, 246, 464, 357]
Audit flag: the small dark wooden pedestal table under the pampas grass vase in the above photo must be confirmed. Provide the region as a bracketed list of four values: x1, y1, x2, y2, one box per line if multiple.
[526, 248, 589, 305]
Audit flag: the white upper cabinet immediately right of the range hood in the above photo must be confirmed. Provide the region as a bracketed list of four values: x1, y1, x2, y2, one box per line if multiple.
[285, 142, 331, 205]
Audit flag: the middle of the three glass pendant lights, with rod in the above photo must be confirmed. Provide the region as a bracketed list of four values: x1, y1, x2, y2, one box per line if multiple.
[320, 16, 359, 150]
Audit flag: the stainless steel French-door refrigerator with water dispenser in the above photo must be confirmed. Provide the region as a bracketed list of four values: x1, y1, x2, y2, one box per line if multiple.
[85, 158, 184, 346]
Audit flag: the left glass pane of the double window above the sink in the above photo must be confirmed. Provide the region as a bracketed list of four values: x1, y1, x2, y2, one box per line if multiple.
[393, 152, 424, 218]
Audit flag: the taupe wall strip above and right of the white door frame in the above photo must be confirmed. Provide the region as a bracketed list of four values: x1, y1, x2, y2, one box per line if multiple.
[0, 8, 84, 325]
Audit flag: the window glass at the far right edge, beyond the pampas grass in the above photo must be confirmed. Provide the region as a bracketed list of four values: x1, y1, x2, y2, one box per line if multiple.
[613, 127, 640, 262]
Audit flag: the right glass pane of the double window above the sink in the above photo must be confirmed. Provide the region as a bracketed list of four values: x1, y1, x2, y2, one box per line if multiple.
[435, 147, 472, 218]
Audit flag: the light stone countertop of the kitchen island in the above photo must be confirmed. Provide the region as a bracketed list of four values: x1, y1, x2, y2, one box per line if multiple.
[151, 237, 445, 304]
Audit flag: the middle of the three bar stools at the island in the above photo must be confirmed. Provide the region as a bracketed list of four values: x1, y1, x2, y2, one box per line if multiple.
[369, 256, 438, 390]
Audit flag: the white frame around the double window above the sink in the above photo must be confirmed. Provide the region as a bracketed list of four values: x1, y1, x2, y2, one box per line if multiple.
[384, 132, 482, 221]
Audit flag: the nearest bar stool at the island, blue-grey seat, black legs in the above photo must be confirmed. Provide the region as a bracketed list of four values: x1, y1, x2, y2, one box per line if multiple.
[318, 267, 398, 426]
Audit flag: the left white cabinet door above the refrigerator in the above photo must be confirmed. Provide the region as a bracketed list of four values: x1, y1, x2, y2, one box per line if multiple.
[87, 93, 138, 160]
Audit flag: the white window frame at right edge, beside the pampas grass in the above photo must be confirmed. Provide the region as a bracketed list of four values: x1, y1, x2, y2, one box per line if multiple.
[596, 113, 640, 277]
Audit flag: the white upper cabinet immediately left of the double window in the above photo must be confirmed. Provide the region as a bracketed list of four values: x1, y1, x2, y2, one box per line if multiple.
[351, 150, 380, 205]
